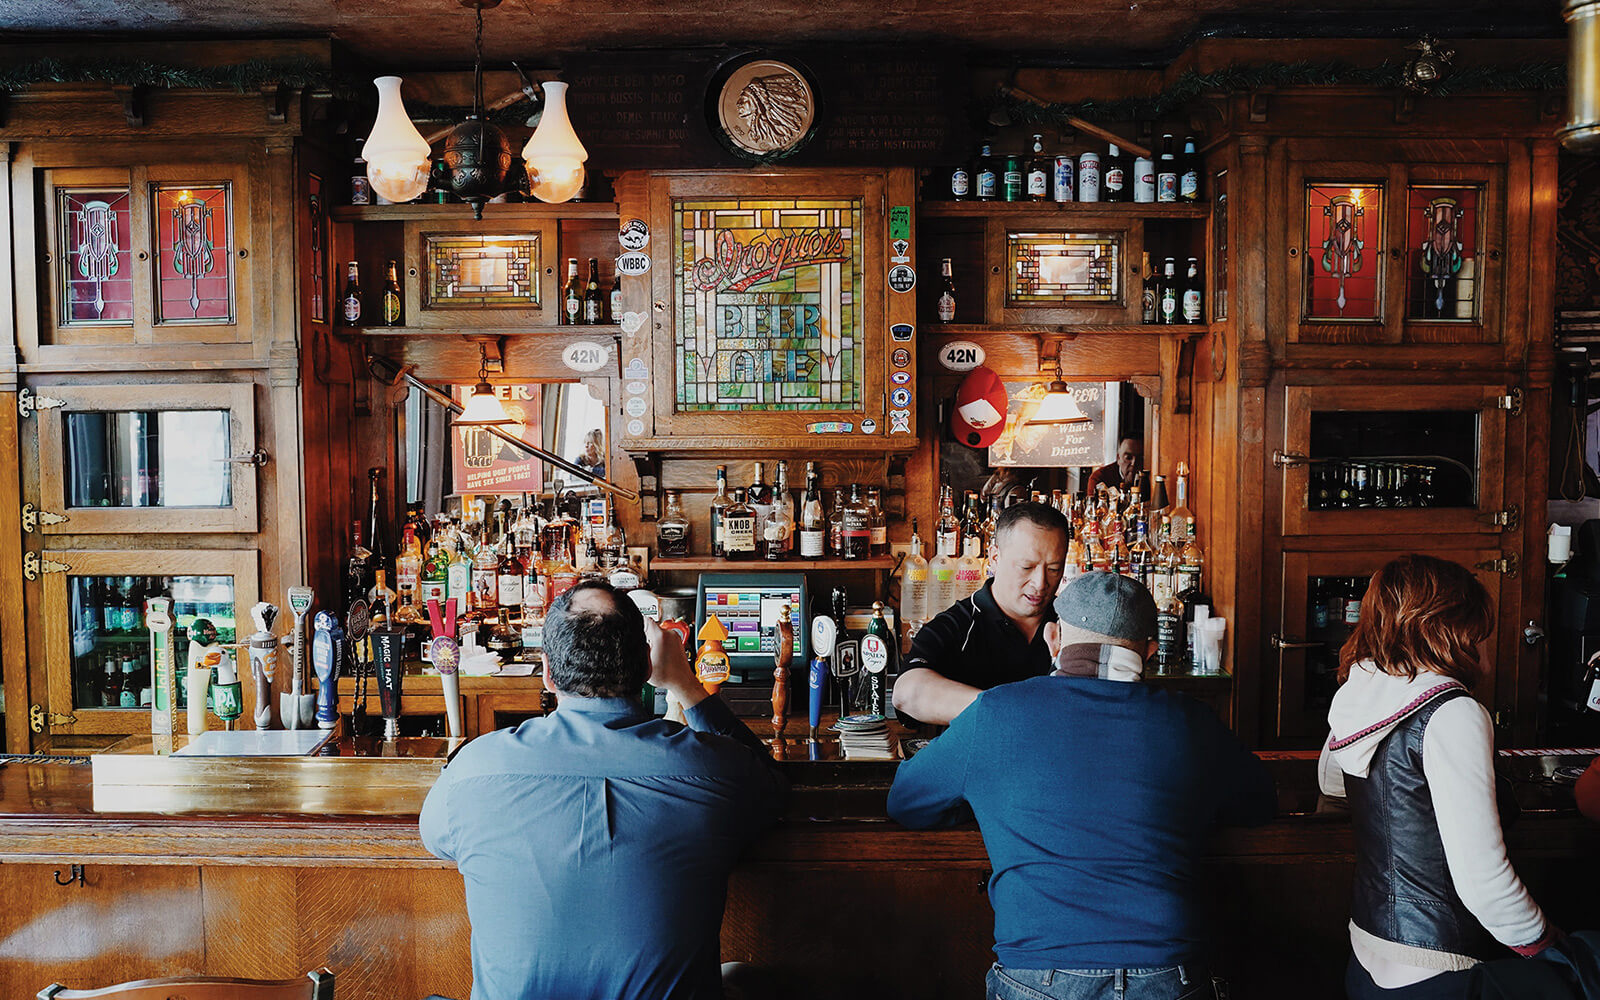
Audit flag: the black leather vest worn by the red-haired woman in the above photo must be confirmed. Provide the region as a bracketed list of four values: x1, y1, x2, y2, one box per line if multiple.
[1344, 688, 1494, 958]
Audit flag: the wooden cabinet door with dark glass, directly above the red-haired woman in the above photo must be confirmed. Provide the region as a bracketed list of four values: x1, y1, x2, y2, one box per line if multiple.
[1274, 386, 1507, 534]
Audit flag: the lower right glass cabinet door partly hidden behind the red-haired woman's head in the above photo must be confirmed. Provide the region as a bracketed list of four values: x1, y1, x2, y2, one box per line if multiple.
[1266, 549, 1501, 749]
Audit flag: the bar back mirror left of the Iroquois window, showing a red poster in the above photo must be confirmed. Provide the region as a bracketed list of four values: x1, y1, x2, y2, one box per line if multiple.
[400, 381, 611, 512]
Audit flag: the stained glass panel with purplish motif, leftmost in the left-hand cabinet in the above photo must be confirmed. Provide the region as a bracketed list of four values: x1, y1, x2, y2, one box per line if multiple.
[56, 187, 133, 326]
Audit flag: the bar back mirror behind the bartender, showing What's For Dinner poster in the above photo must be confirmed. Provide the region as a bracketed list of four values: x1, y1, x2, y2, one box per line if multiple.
[939, 378, 1157, 514]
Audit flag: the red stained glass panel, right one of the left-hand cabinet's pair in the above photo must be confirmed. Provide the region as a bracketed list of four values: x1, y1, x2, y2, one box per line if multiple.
[152, 184, 234, 323]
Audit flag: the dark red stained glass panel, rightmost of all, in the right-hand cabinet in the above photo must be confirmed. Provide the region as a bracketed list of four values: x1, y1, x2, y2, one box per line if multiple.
[1405, 184, 1483, 323]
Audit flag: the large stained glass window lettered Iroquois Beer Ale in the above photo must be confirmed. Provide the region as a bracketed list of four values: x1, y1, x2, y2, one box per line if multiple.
[672, 198, 864, 411]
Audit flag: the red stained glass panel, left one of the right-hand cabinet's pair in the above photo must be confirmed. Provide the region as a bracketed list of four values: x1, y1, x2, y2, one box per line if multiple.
[1302, 184, 1384, 322]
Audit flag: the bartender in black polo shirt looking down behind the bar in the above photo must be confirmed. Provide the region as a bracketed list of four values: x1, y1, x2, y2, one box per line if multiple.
[894, 504, 1069, 725]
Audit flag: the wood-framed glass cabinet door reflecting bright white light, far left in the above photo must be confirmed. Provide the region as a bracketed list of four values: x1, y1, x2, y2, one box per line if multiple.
[38, 382, 256, 534]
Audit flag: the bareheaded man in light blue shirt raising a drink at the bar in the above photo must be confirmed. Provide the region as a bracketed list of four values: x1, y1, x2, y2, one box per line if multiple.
[421, 582, 782, 1000]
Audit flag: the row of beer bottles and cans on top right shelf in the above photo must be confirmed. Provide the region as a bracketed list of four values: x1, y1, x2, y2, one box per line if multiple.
[950, 133, 1202, 203]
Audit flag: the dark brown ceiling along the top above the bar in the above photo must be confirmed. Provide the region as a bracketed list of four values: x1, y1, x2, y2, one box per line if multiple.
[0, 0, 1563, 69]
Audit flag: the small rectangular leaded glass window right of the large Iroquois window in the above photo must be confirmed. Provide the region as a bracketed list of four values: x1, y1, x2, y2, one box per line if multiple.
[1006, 232, 1122, 306]
